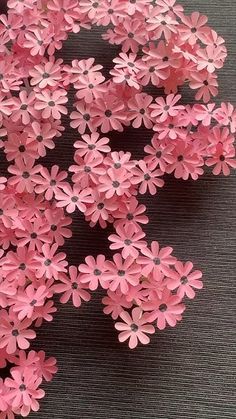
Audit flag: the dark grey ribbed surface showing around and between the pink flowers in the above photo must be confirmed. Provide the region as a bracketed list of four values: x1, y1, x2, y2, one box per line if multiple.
[0, 0, 236, 419]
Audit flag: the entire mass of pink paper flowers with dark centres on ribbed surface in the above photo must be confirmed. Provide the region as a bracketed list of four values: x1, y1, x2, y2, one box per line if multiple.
[0, 0, 236, 419]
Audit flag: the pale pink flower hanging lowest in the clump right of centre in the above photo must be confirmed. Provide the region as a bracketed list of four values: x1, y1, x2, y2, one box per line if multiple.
[115, 307, 155, 349]
